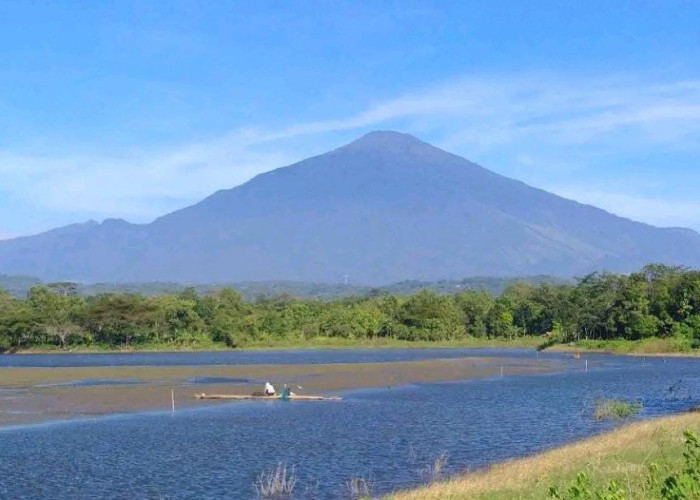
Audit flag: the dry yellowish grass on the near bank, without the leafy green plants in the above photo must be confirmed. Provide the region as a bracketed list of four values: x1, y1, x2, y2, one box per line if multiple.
[390, 413, 700, 500]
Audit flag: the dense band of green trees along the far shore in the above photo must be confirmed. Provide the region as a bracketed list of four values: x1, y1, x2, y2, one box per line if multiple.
[0, 265, 700, 350]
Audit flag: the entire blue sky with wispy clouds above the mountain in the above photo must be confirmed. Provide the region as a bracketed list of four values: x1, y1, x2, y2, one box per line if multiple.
[0, 0, 700, 238]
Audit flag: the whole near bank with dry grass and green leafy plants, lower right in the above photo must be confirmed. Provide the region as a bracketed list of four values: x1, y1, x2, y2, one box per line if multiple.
[391, 413, 700, 500]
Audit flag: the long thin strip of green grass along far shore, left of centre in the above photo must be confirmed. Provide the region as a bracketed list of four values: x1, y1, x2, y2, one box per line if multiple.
[17, 337, 542, 354]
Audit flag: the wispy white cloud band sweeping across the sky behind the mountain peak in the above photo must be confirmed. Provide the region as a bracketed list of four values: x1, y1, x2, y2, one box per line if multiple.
[0, 75, 700, 234]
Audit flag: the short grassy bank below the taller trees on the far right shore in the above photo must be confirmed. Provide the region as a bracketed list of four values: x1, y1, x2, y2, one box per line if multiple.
[546, 337, 700, 356]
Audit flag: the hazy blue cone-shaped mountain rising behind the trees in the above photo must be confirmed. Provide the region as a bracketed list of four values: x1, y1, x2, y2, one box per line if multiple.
[0, 132, 700, 285]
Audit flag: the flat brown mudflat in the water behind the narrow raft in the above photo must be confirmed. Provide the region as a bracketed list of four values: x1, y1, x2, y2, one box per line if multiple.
[0, 357, 554, 426]
